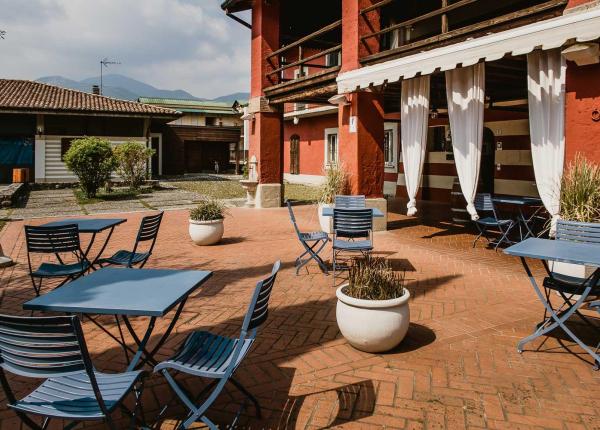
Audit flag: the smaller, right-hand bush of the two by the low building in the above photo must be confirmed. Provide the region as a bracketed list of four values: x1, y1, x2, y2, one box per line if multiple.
[114, 142, 155, 190]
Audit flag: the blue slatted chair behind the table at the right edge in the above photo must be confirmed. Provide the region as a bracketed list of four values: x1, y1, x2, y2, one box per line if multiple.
[543, 220, 600, 332]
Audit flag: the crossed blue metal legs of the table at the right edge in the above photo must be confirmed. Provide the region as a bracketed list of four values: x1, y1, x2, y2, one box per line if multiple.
[517, 257, 600, 363]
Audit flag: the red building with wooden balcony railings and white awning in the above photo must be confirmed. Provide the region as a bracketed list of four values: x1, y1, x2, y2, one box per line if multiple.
[222, 0, 600, 222]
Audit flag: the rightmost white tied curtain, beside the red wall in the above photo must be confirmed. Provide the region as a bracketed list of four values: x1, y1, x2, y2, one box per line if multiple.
[527, 49, 566, 233]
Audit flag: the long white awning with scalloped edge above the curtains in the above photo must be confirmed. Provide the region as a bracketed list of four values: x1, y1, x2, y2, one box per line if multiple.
[337, 7, 600, 94]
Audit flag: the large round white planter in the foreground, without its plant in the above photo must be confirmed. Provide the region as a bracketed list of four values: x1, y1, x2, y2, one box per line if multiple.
[336, 284, 410, 352]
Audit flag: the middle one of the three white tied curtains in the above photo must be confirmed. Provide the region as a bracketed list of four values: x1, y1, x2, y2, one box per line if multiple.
[446, 63, 485, 221]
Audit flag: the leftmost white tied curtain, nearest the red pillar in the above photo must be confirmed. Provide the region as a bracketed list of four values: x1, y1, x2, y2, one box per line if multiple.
[400, 75, 430, 216]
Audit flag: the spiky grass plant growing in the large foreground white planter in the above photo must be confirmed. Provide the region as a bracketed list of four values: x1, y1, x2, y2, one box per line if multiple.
[343, 255, 404, 300]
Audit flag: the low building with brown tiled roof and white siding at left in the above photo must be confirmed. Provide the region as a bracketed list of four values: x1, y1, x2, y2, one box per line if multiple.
[0, 79, 181, 183]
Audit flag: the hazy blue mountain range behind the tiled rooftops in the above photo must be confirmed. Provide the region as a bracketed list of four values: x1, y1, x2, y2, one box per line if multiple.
[36, 74, 250, 103]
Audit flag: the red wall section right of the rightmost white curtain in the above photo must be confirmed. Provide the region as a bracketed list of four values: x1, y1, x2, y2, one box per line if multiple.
[565, 63, 600, 163]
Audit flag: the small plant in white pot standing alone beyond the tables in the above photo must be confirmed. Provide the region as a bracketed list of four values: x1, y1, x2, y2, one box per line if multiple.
[189, 199, 226, 246]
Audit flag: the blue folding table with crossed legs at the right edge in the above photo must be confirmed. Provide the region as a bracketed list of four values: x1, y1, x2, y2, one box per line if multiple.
[504, 238, 600, 368]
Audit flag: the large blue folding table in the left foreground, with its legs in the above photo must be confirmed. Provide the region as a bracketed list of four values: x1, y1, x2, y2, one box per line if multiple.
[23, 267, 212, 371]
